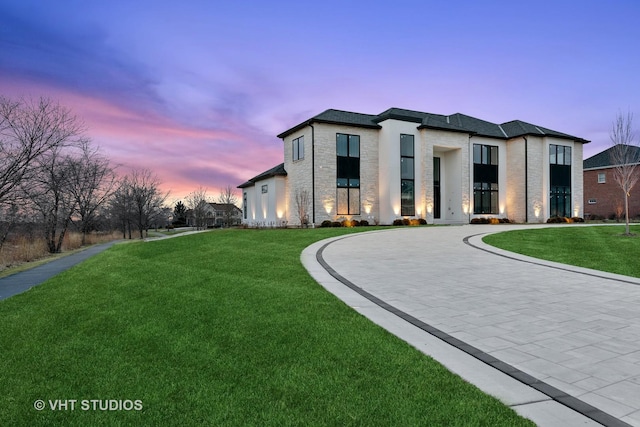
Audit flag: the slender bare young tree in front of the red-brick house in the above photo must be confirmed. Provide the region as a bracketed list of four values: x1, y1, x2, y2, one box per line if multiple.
[609, 112, 640, 235]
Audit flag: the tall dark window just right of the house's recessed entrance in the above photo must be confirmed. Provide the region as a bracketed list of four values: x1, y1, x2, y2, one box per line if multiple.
[473, 144, 499, 214]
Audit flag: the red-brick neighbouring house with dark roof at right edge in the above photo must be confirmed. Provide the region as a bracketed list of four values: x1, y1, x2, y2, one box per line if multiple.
[582, 146, 640, 219]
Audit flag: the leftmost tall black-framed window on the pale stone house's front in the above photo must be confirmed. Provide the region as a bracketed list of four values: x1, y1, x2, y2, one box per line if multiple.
[336, 133, 360, 215]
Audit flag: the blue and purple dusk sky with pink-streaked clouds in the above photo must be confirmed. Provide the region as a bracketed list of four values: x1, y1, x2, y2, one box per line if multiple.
[0, 0, 640, 200]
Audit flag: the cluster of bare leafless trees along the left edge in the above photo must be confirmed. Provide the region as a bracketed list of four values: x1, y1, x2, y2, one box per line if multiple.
[0, 95, 170, 253]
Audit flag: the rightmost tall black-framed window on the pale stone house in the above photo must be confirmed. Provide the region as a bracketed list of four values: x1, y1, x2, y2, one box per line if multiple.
[549, 144, 571, 217]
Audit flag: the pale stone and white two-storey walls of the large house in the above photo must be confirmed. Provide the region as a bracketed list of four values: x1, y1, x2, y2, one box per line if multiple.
[277, 120, 585, 225]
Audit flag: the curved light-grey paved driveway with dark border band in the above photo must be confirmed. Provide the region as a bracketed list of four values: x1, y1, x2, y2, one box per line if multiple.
[302, 225, 640, 426]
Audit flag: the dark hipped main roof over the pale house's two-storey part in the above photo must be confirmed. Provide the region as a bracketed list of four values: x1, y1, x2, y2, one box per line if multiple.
[278, 108, 589, 144]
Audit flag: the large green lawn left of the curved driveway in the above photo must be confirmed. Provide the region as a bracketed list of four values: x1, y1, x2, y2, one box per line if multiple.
[0, 229, 533, 426]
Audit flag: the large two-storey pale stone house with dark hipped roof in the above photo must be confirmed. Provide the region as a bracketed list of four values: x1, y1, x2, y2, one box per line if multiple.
[239, 108, 589, 226]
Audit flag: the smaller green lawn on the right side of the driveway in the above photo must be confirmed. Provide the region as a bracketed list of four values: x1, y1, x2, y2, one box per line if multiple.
[482, 225, 640, 277]
